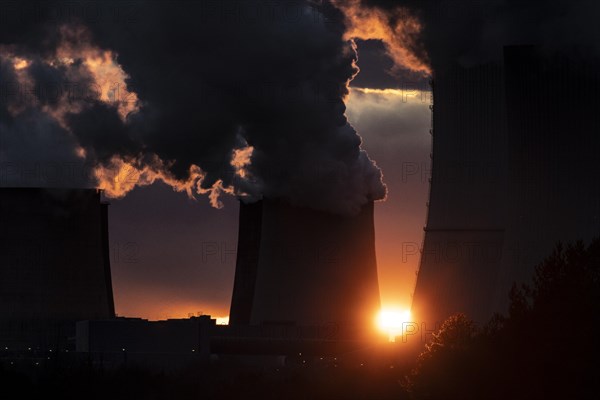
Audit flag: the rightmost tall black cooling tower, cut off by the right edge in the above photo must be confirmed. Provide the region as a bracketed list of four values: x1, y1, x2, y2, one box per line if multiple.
[499, 46, 600, 307]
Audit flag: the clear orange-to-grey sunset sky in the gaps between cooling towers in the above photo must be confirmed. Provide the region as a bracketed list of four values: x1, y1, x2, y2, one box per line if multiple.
[110, 78, 431, 319]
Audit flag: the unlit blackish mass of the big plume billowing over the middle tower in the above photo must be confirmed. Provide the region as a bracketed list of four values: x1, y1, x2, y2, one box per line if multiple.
[0, 1, 385, 216]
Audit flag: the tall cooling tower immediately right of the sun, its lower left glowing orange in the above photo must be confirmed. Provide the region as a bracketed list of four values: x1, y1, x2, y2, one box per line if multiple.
[412, 64, 506, 328]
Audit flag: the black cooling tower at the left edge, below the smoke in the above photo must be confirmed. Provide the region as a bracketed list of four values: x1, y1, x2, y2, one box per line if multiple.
[0, 188, 114, 349]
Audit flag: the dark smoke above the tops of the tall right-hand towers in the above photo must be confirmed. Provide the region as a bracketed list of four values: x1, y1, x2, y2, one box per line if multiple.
[362, 0, 600, 70]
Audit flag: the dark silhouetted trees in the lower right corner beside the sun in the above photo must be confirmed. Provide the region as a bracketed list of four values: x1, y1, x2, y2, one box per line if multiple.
[404, 240, 600, 400]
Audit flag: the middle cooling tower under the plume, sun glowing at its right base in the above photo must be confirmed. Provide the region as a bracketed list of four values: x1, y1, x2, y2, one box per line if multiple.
[231, 199, 380, 335]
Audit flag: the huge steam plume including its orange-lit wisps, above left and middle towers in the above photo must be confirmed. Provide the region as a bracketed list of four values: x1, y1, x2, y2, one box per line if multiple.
[0, 1, 428, 213]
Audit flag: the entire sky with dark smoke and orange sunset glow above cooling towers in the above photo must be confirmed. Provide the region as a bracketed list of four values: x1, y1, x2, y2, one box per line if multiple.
[0, 0, 600, 319]
